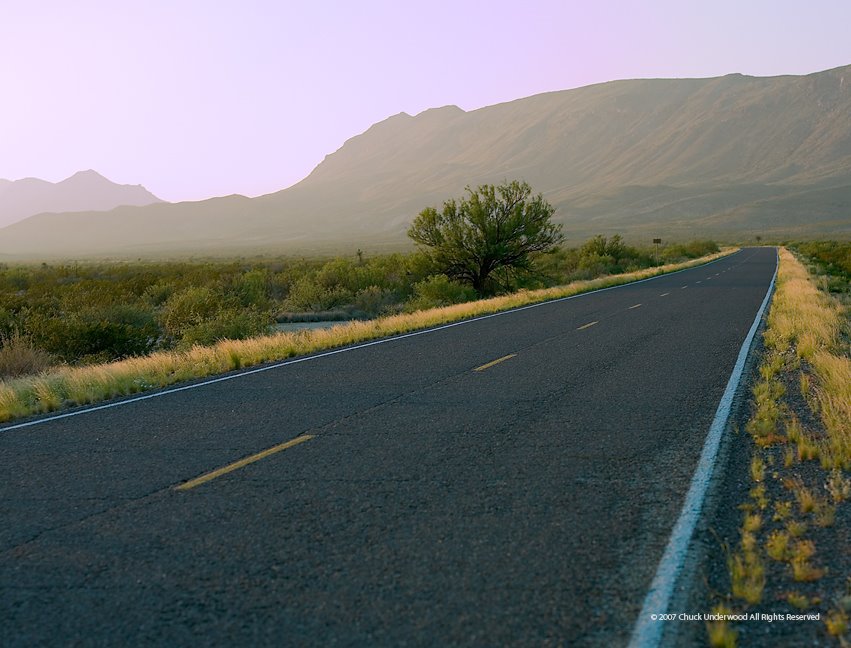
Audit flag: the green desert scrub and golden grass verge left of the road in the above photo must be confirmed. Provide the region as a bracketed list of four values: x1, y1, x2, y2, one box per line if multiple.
[0, 236, 719, 421]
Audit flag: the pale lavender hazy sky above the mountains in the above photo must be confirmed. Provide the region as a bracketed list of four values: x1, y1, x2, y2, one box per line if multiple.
[0, 0, 851, 200]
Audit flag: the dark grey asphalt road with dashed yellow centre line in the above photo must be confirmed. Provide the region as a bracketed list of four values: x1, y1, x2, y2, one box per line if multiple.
[0, 248, 775, 646]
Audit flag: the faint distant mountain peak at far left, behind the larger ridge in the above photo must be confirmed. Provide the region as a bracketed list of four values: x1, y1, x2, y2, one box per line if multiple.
[0, 170, 162, 227]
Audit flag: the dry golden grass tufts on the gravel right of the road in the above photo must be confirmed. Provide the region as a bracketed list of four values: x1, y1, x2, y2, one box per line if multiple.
[708, 250, 851, 645]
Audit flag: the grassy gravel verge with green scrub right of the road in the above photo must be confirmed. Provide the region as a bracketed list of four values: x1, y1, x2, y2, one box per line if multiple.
[707, 243, 851, 646]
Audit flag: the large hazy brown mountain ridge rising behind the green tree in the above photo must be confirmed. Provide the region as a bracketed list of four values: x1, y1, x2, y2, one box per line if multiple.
[0, 66, 851, 256]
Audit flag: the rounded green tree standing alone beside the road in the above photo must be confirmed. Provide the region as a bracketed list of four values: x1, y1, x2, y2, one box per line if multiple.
[408, 180, 564, 294]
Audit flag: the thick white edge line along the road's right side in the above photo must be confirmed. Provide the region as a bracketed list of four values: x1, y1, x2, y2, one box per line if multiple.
[629, 251, 780, 648]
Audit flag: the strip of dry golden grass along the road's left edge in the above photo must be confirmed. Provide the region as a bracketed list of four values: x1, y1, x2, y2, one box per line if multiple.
[0, 248, 735, 422]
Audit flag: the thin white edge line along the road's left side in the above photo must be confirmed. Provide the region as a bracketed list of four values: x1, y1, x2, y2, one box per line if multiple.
[0, 249, 742, 433]
